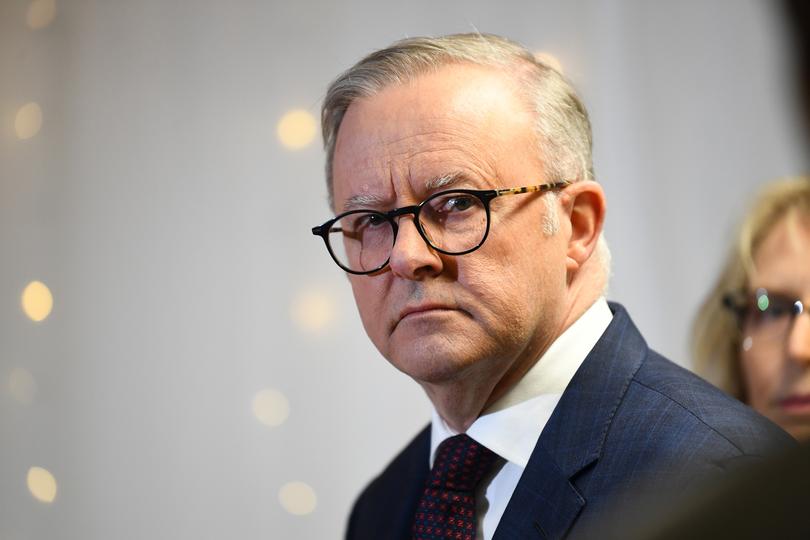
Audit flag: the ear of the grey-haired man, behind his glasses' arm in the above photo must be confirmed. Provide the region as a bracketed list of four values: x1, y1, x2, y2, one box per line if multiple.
[561, 180, 606, 275]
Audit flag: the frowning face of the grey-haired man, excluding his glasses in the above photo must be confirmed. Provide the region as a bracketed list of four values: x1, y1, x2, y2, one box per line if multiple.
[333, 65, 570, 392]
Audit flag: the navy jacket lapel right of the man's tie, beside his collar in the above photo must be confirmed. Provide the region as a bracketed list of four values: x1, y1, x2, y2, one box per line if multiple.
[493, 304, 647, 540]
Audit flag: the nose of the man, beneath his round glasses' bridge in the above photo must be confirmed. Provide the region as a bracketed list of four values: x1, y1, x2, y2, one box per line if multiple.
[388, 215, 444, 281]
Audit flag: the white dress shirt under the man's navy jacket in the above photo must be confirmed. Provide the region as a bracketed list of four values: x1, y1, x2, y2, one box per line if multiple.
[430, 298, 613, 540]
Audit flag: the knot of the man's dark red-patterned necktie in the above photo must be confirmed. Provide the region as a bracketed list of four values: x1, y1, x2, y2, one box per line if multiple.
[428, 433, 498, 491]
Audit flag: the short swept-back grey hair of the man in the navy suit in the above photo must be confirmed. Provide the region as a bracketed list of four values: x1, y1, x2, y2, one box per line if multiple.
[321, 33, 594, 208]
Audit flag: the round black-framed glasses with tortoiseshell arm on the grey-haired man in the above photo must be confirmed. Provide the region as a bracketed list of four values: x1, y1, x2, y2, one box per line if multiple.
[312, 181, 571, 274]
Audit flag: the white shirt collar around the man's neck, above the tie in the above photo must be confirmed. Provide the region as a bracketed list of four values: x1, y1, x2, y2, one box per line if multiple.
[430, 297, 613, 467]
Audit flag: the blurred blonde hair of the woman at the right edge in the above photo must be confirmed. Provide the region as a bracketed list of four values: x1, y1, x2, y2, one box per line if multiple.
[692, 176, 810, 401]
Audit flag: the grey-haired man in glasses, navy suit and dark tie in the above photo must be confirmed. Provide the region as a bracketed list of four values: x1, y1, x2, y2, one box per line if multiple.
[313, 34, 789, 539]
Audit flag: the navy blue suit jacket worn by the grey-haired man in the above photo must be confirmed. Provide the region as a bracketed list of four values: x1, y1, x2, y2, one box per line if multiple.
[346, 304, 793, 540]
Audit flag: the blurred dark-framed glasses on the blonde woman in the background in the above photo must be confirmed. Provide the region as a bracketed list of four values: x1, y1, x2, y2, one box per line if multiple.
[723, 288, 805, 339]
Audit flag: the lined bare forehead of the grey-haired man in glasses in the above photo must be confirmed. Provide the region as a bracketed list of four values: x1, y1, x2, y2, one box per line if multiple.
[332, 64, 539, 210]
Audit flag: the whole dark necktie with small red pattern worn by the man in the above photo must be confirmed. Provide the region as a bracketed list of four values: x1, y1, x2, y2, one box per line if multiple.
[413, 434, 498, 540]
